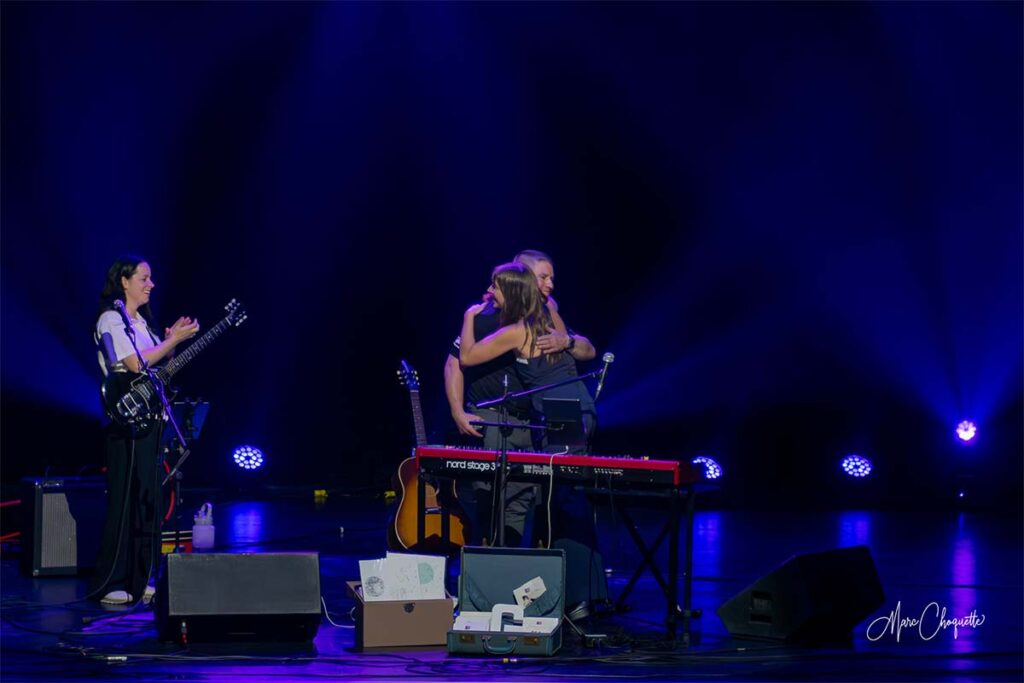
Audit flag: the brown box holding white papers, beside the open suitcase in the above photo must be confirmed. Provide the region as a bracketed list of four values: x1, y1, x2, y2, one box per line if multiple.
[346, 581, 455, 649]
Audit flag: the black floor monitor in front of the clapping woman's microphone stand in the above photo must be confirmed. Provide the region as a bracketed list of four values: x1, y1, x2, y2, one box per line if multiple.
[157, 553, 321, 643]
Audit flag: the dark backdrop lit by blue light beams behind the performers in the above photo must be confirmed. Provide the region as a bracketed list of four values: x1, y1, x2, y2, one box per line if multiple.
[0, 3, 1024, 505]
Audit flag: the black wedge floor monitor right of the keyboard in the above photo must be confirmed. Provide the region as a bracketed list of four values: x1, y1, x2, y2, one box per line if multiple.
[718, 546, 885, 644]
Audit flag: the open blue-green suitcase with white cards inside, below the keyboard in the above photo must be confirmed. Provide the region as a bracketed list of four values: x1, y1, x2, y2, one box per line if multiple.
[447, 548, 565, 656]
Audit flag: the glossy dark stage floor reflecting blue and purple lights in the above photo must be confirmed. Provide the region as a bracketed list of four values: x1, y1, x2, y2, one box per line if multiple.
[0, 492, 1024, 681]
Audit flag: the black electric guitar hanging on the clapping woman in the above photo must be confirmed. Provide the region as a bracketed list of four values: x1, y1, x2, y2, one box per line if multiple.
[100, 299, 247, 438]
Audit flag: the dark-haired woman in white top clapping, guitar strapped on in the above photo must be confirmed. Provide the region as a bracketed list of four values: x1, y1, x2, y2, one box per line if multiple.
[90, 256, 199, 604]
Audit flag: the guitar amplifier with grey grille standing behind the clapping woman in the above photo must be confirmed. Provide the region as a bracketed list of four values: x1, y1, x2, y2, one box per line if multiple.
[22, 477, 106, 577]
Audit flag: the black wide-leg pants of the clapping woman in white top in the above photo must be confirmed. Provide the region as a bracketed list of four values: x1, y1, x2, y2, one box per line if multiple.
[89, 425, 164, 599]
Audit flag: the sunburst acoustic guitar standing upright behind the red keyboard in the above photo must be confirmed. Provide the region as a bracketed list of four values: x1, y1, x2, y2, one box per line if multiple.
[388, 360, 467, 553]
